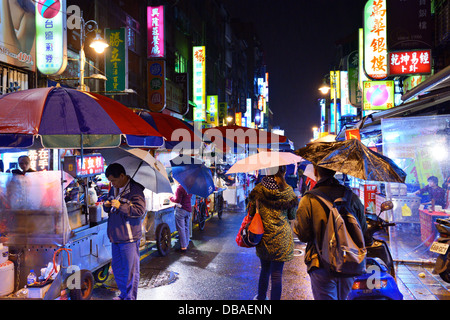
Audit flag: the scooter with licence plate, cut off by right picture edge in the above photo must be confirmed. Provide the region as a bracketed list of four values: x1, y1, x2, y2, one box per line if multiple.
[430, 218, 450, 283]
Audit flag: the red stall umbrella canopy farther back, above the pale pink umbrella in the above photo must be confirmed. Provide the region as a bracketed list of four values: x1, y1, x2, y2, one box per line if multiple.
[203, 125, 287, 150]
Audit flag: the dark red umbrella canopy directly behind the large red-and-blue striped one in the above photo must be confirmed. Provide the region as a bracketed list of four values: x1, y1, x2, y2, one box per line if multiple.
[135, 110, 202, 150]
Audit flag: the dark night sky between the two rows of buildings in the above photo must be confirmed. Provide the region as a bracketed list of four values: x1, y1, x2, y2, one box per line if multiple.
[222, 0, 366, 149]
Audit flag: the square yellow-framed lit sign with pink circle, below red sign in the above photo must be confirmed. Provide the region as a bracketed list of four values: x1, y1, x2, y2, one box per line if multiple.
[363, 80, 394, 110]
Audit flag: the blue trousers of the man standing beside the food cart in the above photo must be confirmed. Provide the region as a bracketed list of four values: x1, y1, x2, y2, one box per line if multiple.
[111, 241, 140, 300]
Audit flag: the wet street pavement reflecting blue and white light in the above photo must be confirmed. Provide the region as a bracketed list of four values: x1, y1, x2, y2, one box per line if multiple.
[92, 204, 450, 300]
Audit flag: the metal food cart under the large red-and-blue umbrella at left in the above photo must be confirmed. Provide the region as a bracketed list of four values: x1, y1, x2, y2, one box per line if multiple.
[0, 171, 111, 299]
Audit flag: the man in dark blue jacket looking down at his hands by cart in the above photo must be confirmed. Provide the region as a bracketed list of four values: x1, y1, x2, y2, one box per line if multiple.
[103, 163, 145, 300]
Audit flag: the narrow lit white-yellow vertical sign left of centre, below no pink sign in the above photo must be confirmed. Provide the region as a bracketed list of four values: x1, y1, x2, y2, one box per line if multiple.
[193, 46, 206, 121]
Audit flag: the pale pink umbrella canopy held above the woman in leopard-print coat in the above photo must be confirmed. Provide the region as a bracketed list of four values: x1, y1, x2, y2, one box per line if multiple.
[227, 151, 303, 174]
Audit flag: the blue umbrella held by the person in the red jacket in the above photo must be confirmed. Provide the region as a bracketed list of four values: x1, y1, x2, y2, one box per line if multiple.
[170, 157, 215, 198]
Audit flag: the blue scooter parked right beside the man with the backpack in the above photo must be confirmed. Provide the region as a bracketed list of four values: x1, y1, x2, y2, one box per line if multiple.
[347, 201, 403, 300]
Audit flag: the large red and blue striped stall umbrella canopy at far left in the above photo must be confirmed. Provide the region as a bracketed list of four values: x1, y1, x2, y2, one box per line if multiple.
[0, 87, 163, 149]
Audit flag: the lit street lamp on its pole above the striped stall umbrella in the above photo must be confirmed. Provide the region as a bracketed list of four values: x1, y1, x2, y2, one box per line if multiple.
[80, 12, 109, 91]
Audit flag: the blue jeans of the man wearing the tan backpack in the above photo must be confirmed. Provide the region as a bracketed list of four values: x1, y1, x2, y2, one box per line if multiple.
[309, 268, 353, 300]
